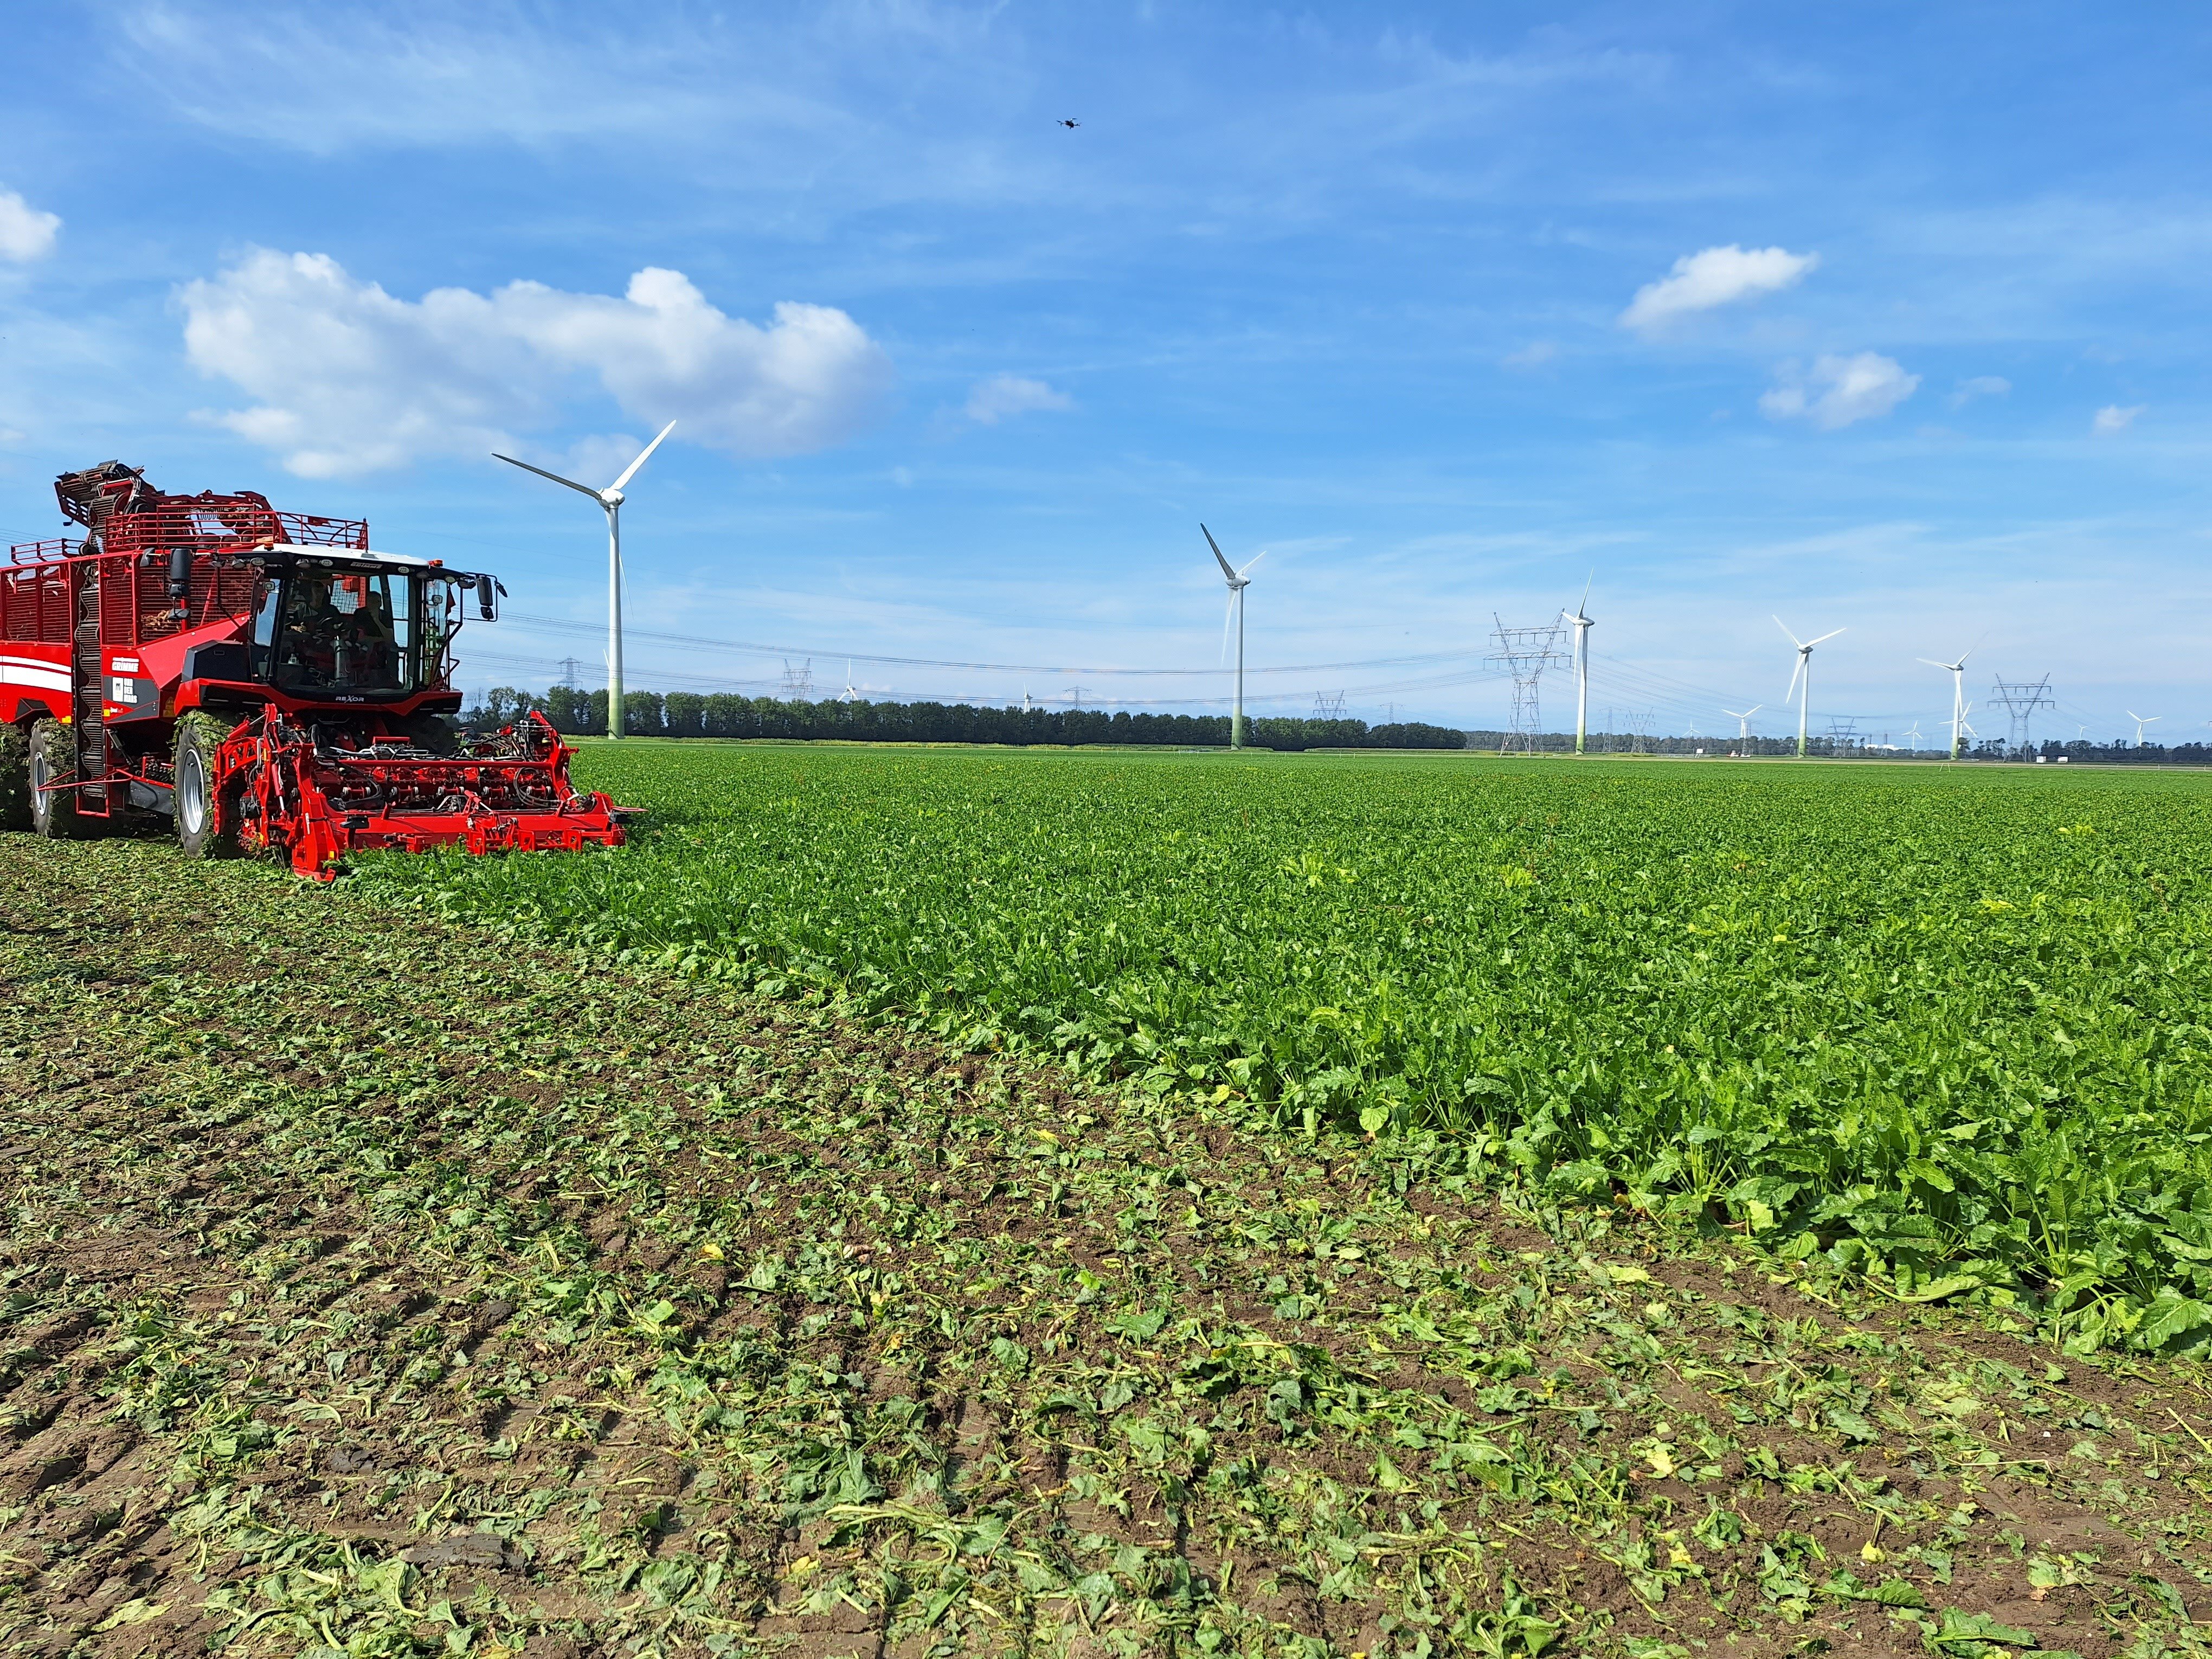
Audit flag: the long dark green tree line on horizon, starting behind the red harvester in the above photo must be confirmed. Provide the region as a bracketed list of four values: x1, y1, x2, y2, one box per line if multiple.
[462, 686, 1467, 750]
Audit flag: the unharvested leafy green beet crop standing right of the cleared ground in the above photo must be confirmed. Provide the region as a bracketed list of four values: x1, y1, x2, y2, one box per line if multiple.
[353, 745, 2212, 1347]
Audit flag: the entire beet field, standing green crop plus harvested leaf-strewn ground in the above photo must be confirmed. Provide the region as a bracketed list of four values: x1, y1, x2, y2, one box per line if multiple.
[12, 741, 2212, 1659]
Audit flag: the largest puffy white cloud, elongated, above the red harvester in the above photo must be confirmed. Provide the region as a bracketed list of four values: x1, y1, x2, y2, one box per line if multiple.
[182, 250, 889, 478]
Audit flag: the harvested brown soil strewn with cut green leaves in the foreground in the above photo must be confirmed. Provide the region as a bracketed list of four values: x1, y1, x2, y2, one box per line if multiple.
[0, 838, 2212, 1659]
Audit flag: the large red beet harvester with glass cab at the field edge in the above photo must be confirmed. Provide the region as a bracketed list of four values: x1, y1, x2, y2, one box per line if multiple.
[0, 462, 626, 880]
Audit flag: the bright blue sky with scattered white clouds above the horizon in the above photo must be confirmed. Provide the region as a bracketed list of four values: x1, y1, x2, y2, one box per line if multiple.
[0, 0, 2212, 739]
